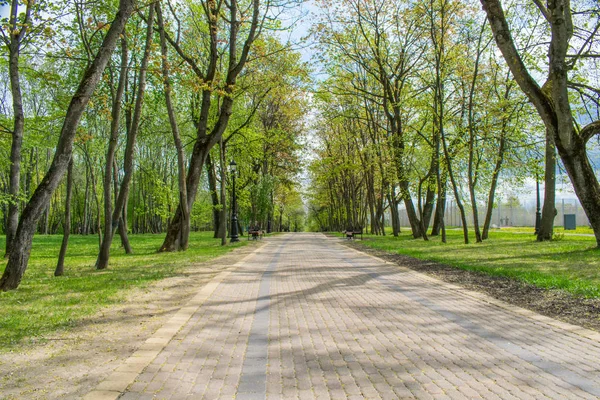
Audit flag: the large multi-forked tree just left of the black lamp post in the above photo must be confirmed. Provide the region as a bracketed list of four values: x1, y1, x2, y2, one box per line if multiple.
[160, 0, 270, 251]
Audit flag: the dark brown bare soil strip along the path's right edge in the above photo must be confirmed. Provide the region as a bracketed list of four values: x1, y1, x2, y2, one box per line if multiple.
[345, 242, 600, 332]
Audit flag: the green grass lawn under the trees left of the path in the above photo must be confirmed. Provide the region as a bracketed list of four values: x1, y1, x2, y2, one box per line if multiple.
[0, 232, 246, 351]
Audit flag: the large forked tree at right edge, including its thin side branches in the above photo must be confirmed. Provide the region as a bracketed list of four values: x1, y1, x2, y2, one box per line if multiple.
[481, 0, 600, 247]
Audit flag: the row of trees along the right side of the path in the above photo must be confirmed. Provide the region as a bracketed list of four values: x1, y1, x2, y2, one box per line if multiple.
[309, 0, 600, 245]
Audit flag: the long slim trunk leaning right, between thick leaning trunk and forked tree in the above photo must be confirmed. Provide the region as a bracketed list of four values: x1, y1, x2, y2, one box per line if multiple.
[96, 6, 155, 269]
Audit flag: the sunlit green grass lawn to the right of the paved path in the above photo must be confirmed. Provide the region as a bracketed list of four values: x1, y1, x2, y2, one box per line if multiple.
[356, 228, 600, 298]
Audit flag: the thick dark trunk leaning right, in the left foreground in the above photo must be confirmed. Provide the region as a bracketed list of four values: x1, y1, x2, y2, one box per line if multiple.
[0, 0, 134, 291]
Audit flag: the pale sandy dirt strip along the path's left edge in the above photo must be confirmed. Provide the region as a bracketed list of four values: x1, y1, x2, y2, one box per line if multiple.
[0, 244, 259, 400]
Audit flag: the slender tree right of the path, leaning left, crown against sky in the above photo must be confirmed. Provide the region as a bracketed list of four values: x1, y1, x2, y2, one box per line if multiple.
[321, 0, 427, 239]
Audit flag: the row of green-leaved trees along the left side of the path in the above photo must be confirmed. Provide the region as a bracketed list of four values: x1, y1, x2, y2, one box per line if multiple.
[0, 0, 308, 290]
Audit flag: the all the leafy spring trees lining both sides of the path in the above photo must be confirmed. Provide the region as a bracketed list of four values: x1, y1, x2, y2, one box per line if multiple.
[0, 0, 600, 290]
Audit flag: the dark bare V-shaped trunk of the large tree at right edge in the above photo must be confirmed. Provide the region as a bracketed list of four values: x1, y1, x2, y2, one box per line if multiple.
[480, 0, 600, 247]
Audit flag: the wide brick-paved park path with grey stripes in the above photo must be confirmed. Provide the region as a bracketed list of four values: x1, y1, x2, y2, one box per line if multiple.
[86, 234, 600, 400]
